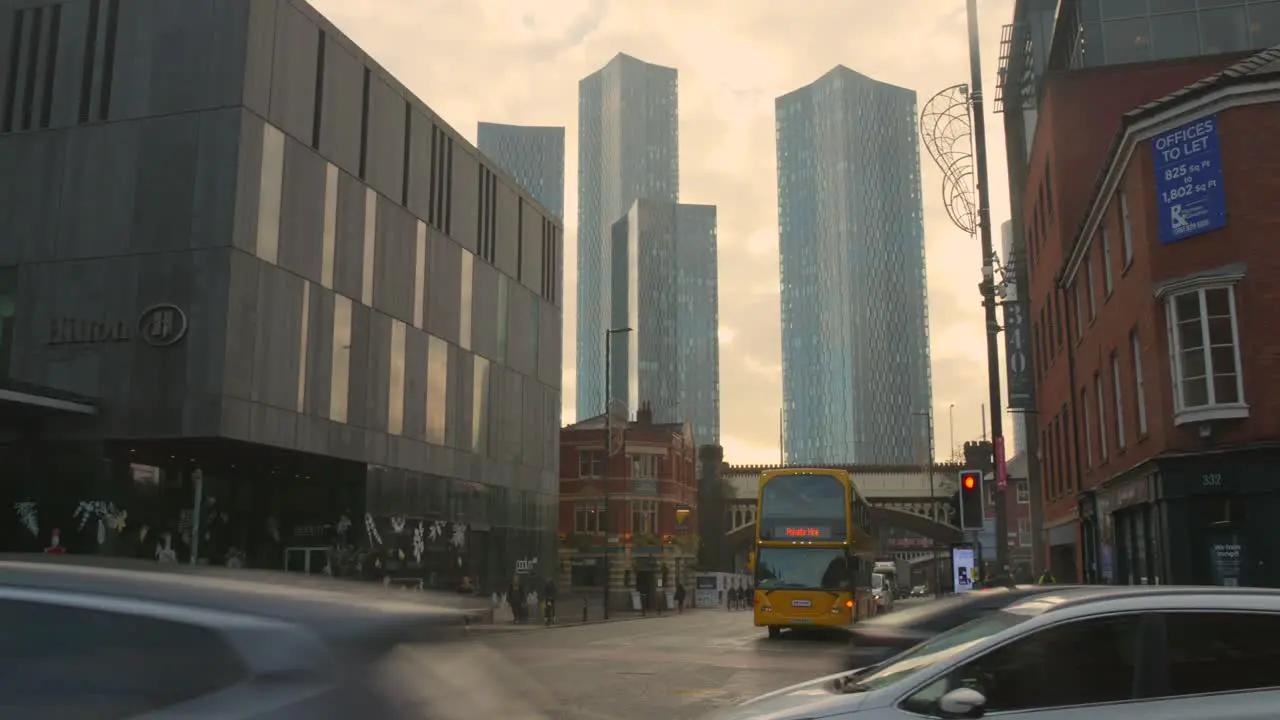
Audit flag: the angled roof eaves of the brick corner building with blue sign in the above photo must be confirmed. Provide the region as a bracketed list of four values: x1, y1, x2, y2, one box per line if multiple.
[1053, 45, 1280, 288]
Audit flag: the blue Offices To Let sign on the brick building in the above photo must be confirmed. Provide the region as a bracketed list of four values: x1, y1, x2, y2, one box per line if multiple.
[1151, 115, 1226, 242]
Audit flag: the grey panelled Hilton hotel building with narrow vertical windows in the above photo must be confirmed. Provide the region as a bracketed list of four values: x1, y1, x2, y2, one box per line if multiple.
[0, 0, 562, 587]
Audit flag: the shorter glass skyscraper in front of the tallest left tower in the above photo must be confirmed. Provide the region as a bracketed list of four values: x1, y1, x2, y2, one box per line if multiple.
[609, 199, 719, 445]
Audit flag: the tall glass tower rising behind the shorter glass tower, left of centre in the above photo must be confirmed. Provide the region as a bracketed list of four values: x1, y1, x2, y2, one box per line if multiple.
[577, 54, 680, 420]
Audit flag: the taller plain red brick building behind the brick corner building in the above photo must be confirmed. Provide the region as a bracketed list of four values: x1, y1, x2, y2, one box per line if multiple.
[1015, 50, 1242, 580]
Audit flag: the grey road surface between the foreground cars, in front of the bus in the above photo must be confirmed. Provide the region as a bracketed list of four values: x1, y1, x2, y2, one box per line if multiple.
[473, 601, 901, 720]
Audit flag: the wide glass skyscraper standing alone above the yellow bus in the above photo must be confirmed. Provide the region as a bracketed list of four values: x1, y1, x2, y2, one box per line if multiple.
[776, 65, 932, 465]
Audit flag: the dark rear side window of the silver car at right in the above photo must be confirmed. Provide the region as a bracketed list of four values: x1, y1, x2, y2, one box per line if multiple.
[1164, 612, 1280, 697]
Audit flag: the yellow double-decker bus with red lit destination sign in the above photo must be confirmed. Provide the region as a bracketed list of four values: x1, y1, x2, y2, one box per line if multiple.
[751, 468, 876, 638]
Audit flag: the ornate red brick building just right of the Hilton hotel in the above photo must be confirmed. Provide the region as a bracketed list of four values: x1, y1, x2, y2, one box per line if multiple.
[557, 404, 698, 607]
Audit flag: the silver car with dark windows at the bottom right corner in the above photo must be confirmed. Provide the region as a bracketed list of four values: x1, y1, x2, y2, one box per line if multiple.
[713, 587, 1280, 720]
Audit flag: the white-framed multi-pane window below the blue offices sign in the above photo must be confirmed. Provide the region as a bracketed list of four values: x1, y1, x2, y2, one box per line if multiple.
[1166, 286, 1249, 424]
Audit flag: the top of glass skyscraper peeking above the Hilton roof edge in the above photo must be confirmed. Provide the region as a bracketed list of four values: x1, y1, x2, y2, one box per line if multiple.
[476, 123, 564, 219]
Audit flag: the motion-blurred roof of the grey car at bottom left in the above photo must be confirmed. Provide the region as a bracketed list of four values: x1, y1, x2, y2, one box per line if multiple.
[0, 553, 476, 643]
